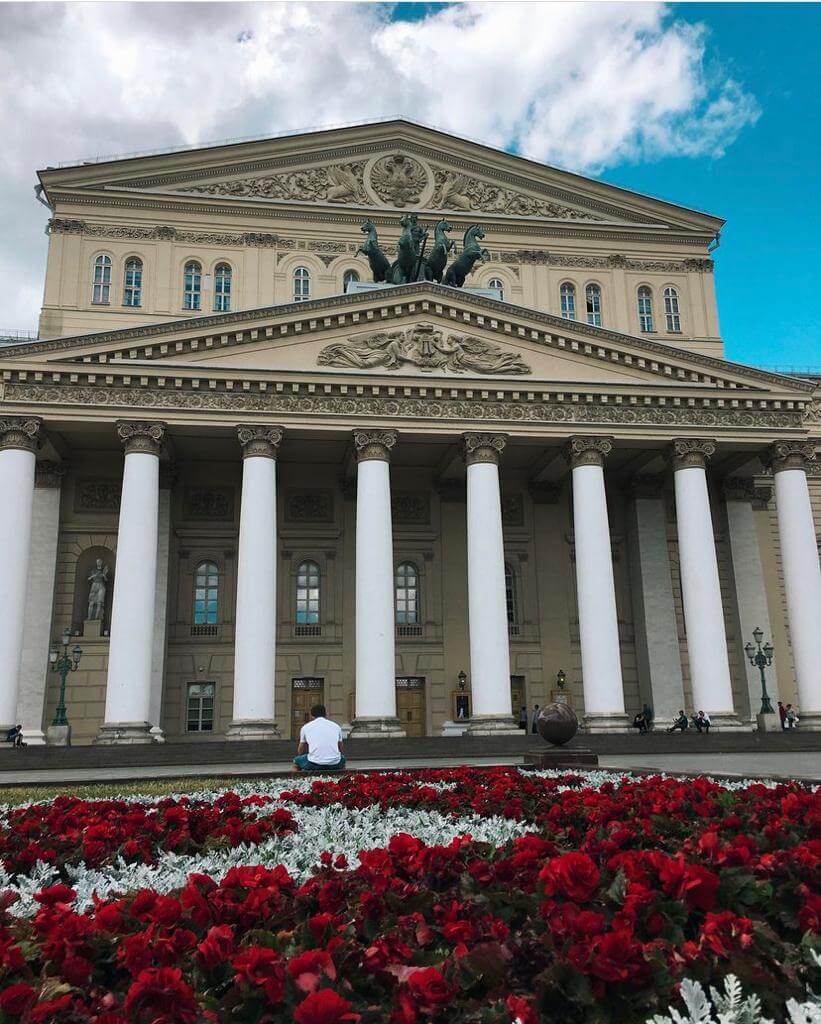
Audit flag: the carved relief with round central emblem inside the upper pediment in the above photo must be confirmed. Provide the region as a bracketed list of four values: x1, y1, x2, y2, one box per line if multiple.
[180, 153, 601, 220]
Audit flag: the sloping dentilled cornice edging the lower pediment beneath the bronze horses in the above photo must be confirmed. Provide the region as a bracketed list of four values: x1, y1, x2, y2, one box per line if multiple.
[0, 282, 816, 400]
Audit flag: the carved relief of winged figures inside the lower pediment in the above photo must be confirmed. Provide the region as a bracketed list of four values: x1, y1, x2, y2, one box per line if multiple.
[316, 324, 532, 375]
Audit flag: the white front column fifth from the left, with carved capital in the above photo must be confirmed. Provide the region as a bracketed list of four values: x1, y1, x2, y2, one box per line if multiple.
[463, 433, 518, 735]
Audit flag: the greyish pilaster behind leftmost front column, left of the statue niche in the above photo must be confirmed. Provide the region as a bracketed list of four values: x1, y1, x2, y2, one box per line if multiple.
[16, 462, 66, 746]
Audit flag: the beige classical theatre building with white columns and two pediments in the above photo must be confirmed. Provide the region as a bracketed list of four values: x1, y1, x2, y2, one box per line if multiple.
[0, 121, 821, 743]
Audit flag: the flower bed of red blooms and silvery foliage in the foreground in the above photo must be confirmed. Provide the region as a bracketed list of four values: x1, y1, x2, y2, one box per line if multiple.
[0, 768, 821, 1024]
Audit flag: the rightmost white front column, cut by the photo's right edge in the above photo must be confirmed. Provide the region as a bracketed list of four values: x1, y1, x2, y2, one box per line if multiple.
[770, 441, 821, 729]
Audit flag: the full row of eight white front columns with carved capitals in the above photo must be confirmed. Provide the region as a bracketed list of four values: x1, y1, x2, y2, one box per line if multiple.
[0, 417, 821, 743]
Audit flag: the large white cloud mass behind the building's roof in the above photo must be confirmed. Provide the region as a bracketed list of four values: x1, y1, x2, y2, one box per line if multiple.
[0, 2, 759, 327]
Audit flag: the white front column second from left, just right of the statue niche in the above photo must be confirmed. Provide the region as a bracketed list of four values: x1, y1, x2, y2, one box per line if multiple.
[96, 421, 166, 743]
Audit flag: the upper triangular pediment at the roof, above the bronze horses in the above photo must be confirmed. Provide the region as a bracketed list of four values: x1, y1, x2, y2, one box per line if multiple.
[41, 121, 723, 237]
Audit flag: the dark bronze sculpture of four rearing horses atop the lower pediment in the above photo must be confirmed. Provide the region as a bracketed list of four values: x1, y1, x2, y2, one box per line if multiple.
[359, 213, 490, 288]
